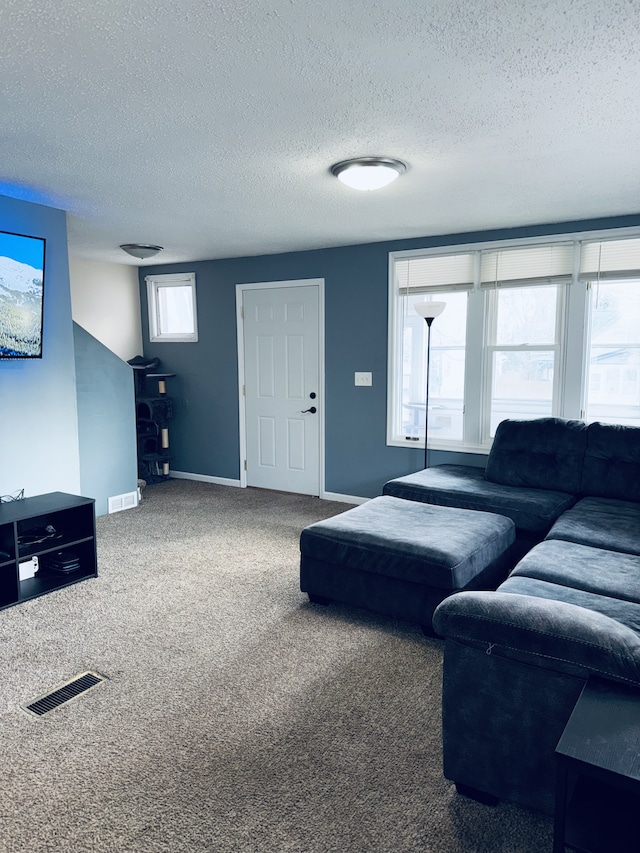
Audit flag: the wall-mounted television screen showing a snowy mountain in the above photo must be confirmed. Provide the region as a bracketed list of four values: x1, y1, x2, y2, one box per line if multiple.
[0, 231, 45, 358]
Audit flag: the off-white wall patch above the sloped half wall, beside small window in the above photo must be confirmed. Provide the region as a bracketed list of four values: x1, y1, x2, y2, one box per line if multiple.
[69, 257, 142, 361]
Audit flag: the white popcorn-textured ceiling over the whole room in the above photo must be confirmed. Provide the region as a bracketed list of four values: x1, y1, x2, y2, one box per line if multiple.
[0, 0, 640, 263]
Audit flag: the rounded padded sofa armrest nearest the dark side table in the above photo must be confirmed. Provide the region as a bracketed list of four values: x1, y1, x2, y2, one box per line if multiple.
[433, 592, 640, 684]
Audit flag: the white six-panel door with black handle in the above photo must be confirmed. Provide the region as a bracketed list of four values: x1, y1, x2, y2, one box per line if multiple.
[243, 285, 320, 495]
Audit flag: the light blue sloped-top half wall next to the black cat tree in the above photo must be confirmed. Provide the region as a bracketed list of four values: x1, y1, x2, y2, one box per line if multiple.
[73, 323, 138, 515]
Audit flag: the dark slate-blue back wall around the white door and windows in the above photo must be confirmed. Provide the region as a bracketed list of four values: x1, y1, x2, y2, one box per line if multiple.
[140, 214, 640, 497]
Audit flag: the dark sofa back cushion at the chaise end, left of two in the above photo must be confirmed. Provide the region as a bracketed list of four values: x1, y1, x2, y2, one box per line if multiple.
[486, 418, 587, 495]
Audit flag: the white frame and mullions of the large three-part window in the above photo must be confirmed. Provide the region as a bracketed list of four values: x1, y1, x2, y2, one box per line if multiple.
[387, 227, 640, 454]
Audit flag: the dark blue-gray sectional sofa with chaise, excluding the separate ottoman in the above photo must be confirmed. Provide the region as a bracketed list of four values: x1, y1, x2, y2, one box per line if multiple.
[384, 418, 640, 813]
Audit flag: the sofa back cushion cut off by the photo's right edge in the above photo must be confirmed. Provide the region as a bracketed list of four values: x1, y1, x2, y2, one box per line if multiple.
[580, 422, 640, 502]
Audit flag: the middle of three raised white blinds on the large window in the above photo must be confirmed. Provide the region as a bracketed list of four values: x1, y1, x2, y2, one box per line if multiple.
[480, 243, 573, 288]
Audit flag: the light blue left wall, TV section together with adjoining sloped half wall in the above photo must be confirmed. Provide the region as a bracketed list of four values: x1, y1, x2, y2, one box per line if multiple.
[0, 196, 137, 514]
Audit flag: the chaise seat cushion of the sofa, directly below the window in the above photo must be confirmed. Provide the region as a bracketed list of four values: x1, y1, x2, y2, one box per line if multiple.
[383, 465, 576, 533]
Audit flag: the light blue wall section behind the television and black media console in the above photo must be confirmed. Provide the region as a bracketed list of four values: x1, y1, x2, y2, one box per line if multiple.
[0, 196, 80, 496]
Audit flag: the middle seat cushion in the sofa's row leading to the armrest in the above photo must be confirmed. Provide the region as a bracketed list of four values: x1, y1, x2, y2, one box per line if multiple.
[510, 540, 640, 604]
